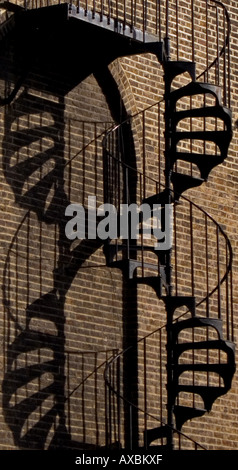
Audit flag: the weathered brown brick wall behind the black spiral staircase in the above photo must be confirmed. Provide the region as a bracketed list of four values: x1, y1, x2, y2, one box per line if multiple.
[0, 0, 238, 450]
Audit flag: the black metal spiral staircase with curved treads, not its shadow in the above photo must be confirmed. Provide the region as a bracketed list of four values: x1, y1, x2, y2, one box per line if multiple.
[101, 1, 235, 445]
